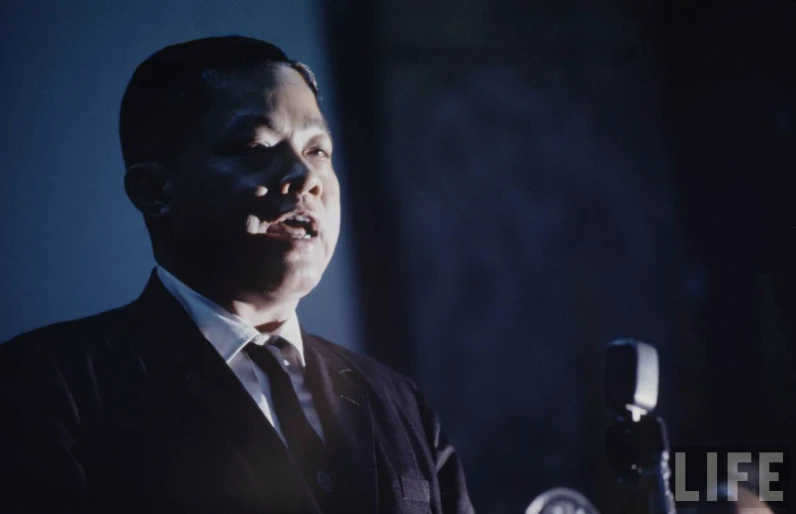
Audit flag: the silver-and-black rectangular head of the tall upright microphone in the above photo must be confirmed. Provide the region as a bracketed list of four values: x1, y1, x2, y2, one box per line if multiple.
[605, 339, 658, 419]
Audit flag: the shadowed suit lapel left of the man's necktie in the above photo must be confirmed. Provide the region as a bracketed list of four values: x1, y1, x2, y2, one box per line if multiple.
[134, 272, 320, 512]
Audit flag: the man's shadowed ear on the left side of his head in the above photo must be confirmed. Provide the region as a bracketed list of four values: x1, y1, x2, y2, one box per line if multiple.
[124, 162, 173, 219]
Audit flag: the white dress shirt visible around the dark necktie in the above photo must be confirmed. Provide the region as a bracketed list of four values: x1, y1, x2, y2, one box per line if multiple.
[157, 265, 324, 441]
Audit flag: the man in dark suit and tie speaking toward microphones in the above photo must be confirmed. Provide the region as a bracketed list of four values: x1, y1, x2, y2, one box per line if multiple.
[0, 37, 472, 513]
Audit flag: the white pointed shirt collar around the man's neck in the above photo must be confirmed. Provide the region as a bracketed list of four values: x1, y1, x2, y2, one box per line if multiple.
[157, 264, 304, 366]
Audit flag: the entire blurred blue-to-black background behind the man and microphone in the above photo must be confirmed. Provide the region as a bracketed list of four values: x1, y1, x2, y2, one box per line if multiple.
[0, 0, 796, 513]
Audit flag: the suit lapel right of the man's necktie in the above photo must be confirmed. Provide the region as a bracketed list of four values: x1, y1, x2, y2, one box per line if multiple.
[302, 330, 378, 513]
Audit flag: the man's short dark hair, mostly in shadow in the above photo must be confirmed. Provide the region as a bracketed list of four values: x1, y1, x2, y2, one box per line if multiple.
[119, 36, 318, 167]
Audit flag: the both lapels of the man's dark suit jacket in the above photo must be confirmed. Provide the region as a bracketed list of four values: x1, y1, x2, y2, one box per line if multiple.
[129, 270, 378, 514]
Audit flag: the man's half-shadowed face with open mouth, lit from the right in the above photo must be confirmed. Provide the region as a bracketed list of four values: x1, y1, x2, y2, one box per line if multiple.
[169, 65, 340, 297]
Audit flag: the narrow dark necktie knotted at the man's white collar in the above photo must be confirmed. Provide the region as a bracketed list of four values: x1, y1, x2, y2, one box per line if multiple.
[244, 338, 333, 503]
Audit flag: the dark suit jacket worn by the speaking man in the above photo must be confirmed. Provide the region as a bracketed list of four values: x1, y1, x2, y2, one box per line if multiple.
[0, 273, 472, 514]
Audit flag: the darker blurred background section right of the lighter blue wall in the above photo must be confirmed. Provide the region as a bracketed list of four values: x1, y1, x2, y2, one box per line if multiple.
[327, 0, 796, 513]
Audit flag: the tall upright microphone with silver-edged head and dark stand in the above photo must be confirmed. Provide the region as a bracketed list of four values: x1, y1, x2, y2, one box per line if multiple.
[605, 339, 676, 514]
